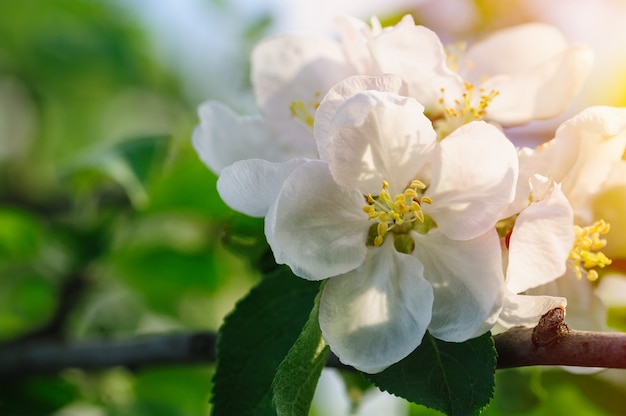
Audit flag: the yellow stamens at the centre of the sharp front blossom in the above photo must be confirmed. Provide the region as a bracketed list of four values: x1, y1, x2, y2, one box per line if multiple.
[363, 180, 433, 252]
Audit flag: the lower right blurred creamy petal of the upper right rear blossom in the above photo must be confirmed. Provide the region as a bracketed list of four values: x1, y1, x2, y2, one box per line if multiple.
[481, 46, 593, 126]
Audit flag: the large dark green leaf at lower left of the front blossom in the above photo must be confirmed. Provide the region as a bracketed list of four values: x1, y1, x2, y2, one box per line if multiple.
[212, 267, 319, 416]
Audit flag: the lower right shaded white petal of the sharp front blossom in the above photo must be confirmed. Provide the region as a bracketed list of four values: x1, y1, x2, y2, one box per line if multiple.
[412, 229, 504, 342]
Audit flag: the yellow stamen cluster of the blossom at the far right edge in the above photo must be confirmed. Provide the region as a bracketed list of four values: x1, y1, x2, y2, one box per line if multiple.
[569, 220, 611, 282]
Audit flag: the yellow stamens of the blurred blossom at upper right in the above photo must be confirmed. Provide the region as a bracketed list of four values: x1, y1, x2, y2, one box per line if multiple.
[433, 82, 499, 140]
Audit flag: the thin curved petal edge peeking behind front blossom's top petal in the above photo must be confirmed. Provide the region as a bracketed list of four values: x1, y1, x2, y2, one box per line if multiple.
[314, 75, 407, 161]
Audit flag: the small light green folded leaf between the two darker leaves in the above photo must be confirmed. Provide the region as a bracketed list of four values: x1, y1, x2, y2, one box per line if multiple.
[272, 292, 330, 416]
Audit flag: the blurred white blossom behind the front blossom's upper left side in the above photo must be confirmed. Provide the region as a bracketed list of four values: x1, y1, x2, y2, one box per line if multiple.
[192, 35, 355, 174]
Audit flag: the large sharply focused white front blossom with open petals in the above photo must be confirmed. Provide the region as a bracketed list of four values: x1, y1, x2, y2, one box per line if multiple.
[218, 77, 517, 373]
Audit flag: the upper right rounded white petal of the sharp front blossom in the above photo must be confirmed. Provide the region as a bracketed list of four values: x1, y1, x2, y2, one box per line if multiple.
[422, 121, 518, 240]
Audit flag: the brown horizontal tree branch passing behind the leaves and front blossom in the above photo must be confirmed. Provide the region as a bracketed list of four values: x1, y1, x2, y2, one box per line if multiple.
[0, 308, 626, 380]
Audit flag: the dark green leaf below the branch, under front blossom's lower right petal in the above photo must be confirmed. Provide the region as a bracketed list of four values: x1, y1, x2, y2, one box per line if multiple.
[367, 332, 496, 415]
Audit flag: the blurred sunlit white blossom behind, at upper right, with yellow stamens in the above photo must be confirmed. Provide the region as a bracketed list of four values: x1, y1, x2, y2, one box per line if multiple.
[340, 15, 593, 136]
